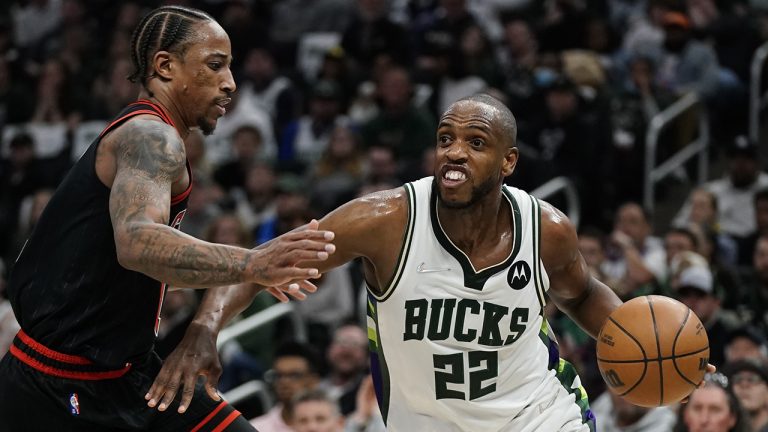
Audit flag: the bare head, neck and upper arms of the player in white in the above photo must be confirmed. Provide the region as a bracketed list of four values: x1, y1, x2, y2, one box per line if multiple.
[152, 101, 712, 412]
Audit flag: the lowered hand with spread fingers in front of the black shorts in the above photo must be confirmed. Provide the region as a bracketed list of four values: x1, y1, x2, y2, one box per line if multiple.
[144, 322, 221, 413]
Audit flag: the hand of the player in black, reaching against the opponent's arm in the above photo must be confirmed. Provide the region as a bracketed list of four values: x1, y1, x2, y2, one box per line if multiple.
[248, 220, 336, 287]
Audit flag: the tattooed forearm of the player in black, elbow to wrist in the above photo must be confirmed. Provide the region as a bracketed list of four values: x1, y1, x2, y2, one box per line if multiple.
[115, 222, 257, 288]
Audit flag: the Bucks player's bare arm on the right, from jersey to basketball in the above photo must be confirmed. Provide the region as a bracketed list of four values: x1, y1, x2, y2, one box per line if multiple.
[541, 201, 621, 338]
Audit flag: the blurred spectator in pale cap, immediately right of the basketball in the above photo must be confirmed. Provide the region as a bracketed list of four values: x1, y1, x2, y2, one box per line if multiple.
[672, 252, 735, 367]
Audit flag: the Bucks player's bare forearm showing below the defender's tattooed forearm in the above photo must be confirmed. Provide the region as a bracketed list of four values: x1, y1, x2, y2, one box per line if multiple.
[193, 284, 264, 334]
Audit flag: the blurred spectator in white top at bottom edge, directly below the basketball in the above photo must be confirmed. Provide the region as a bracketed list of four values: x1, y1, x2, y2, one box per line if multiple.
[589, 391, 677, 432]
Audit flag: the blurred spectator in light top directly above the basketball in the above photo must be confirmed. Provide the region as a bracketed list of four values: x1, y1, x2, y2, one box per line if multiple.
[602, 203, 666, 298]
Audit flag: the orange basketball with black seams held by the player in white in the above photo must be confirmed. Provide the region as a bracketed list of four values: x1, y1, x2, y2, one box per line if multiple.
[597, 295, 709, 407]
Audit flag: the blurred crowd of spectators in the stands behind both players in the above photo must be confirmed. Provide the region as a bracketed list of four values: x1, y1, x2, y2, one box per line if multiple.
[0, 0, 768, 431]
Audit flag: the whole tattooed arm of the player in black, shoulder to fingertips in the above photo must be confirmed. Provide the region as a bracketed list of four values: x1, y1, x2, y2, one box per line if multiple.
[109, 119, 333, 288]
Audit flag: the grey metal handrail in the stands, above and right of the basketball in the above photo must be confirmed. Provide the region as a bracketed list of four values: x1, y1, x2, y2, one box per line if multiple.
[643, 93, 709, 212]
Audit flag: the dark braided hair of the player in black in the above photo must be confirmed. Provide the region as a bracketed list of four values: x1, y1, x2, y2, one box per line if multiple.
[128, 6, 213, 86]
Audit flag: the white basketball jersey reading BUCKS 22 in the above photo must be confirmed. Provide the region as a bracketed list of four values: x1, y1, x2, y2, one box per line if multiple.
[368, 177, 594, 432]
